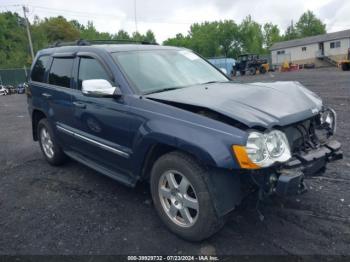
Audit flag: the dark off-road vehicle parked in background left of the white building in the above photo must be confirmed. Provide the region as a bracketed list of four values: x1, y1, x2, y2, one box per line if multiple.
[232, 54, 270, 76]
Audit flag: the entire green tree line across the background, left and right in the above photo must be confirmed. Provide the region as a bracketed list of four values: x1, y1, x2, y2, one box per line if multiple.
[0, 11, 326, 68]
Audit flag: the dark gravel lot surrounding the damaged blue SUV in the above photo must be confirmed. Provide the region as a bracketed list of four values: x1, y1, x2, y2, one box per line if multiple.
[0, 66, 350, 255]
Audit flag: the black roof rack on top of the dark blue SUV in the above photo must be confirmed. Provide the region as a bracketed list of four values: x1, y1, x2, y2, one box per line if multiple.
[49, 39, 158, 48]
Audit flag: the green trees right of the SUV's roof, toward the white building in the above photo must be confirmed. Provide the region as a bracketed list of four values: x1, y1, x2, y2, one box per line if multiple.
[164, 11, 326, 58]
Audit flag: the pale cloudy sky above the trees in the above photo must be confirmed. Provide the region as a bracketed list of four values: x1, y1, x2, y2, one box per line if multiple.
[0, 0, 350, 43]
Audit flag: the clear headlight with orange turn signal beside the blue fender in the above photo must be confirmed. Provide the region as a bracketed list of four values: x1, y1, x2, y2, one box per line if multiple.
[233, 130, 291, 169]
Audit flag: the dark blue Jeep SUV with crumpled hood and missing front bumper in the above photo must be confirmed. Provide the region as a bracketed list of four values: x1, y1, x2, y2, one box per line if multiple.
[27, 41, 342, 240]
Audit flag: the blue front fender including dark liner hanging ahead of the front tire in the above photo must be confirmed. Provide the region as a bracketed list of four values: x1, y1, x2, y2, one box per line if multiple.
[129, 97, 247, 216]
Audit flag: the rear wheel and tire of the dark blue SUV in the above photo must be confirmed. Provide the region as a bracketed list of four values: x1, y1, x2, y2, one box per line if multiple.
[37, 118, 66, 166]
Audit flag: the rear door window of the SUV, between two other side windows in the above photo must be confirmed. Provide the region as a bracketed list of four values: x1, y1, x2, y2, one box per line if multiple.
[49, 58, 73, 88]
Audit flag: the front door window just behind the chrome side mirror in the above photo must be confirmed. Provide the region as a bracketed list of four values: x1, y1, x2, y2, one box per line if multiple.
[78, 57, 111, 90]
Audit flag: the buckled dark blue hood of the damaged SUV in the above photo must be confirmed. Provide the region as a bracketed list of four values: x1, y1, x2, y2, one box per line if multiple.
[146, 82, 322, 128]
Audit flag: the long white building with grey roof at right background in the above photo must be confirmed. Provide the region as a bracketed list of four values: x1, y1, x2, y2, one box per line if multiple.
[270, 30, 350, 66]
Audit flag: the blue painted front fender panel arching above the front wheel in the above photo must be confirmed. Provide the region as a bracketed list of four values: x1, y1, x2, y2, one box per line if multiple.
[126, 97, 247, 175]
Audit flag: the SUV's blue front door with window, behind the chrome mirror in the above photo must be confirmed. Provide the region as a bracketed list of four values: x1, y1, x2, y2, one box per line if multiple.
[72, 56, 132, 176]
